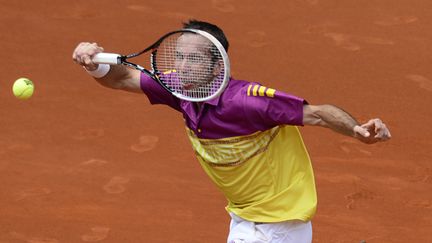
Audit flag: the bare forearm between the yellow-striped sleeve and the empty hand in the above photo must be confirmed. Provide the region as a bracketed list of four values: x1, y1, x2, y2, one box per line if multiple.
[314, 105, 359, 137]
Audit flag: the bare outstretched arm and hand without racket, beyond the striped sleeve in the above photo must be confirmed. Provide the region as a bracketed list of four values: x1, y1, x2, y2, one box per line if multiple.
[303, 105, 391, 144]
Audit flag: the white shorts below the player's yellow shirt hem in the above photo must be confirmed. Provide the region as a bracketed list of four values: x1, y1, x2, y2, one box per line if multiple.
[227, 213, 312, 243]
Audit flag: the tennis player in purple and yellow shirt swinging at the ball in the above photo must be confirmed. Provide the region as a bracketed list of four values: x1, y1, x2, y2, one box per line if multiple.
[73, 20, 391, 243]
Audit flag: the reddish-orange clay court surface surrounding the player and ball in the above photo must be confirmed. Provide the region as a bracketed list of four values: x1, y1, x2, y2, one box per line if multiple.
[0, 0, 432, 243]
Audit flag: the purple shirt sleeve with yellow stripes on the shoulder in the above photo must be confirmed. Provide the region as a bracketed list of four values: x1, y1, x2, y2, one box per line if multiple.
[243, 83, 307, 130]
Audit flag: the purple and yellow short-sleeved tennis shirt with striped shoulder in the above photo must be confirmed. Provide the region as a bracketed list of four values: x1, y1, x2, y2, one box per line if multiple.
[141, 74, 317, 222]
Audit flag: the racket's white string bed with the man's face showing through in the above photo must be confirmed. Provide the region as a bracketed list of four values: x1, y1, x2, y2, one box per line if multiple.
[153, 34, 225, 98]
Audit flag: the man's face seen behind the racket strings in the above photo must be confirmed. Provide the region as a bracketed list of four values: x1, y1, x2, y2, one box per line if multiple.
[175, 34, 221, 90]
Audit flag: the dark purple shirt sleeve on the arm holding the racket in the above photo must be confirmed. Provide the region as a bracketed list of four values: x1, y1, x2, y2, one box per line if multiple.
[140, 73, 181, 111]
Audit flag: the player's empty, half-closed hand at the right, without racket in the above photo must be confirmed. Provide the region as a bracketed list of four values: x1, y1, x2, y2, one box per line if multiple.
[354, 118, 391, 144]
